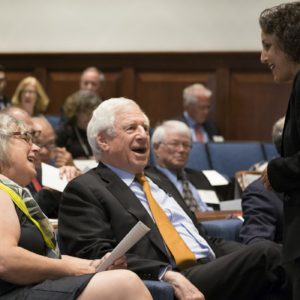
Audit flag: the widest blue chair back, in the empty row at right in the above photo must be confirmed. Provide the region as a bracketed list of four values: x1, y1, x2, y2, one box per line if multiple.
[207, 142, 265, 178]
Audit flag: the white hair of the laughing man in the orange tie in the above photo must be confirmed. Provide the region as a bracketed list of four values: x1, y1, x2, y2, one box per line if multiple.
[87, 98, 149, 161]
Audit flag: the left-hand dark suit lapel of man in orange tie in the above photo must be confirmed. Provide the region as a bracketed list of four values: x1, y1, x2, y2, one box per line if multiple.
[97, 163, 168, 257]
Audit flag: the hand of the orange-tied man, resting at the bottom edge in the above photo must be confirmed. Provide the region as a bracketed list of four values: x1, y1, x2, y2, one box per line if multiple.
[163, 271, 205, 300]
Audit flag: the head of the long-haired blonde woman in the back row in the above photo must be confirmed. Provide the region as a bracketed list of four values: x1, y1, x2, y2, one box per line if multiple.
[12, 77, 49, 116]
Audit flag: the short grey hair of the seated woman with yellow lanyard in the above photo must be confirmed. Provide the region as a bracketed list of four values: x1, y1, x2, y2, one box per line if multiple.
[0, 113, 28, 172]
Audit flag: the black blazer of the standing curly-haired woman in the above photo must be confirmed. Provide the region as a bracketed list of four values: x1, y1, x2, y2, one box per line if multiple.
[268, 71, 300, 261]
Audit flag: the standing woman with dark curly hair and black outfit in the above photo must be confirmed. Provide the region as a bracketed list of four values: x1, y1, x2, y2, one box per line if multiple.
[259, 1, 300, 300]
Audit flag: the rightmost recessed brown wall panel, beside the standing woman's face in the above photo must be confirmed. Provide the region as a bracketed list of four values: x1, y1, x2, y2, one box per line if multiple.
[226, 72, 291, 141]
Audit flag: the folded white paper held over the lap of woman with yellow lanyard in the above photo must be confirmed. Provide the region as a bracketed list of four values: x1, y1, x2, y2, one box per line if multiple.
[96, 221, 150, 272]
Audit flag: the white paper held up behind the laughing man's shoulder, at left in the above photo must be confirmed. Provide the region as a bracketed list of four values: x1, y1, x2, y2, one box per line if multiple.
[42, 163, 68, 192]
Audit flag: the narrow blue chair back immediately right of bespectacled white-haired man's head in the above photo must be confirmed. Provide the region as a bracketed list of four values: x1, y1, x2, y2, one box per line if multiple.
[186, 142, 211, 171]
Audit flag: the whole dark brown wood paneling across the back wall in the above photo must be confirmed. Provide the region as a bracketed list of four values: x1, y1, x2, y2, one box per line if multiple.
[0, 52, 291, 141]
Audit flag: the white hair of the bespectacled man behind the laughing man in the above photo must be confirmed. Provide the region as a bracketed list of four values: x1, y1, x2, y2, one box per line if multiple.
[151, 120, 192, 145]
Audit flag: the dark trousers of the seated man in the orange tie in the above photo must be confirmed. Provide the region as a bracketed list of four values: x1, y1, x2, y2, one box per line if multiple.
[182, 241, 288, 300]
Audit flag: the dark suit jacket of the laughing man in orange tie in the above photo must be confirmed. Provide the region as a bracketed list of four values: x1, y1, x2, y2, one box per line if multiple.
[59, 163, 241, 279]
